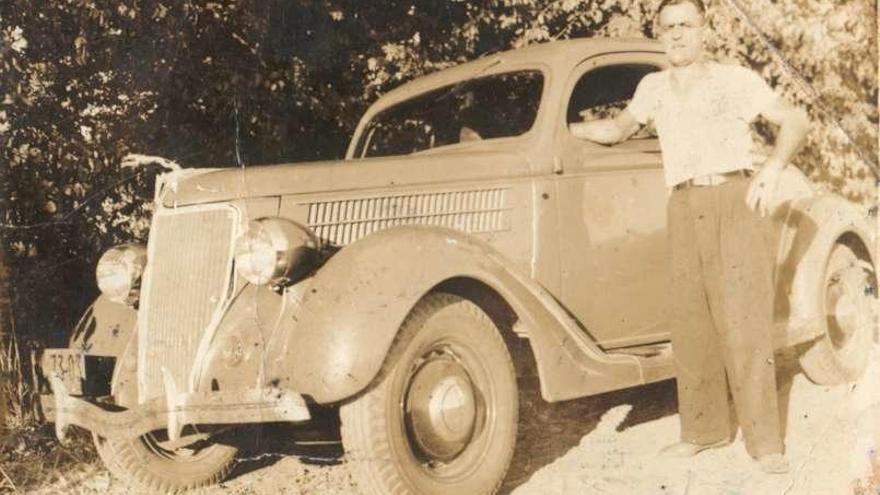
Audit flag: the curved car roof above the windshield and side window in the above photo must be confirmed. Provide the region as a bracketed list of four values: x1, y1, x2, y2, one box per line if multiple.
[369, 38, 662, 114]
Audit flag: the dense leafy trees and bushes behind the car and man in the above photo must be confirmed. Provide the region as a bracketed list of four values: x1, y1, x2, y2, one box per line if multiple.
[0, 0, 878, 422]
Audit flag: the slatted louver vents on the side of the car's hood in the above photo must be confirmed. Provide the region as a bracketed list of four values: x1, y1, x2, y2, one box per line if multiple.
[308, 188, 510, 246]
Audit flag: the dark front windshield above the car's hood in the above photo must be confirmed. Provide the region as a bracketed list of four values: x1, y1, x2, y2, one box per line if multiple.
[356, 70, 544, 156]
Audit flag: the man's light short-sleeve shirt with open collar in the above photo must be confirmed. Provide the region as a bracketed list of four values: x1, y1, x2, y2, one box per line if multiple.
[627, 62, 777, 187]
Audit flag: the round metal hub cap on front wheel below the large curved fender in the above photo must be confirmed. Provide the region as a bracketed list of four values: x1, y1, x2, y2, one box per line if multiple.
[406, 354, 477, 461]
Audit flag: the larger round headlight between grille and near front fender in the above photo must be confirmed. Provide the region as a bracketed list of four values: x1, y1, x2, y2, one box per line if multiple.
[235, 218, 317, 285]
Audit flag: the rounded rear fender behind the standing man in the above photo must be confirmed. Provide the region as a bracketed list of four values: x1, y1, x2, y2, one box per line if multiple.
[777, 195, 876, 345]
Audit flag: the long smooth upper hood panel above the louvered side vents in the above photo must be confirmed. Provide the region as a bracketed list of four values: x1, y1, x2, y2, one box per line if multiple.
[161, 147, 529, 207]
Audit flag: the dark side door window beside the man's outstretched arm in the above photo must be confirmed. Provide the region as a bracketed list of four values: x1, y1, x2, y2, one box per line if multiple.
[566, 64, 660, 137]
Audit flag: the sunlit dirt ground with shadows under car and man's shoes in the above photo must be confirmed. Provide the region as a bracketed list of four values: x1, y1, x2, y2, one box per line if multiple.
[20, 346, 880, 495]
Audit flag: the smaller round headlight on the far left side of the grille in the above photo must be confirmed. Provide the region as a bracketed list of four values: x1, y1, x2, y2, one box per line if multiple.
[95, 244, 147, 304]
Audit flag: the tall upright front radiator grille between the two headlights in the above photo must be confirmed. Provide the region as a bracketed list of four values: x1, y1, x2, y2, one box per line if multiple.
[139, 208, 236, 401]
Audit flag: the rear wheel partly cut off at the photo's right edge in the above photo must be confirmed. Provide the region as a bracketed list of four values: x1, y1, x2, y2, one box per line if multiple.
[800, 244, 877, 385]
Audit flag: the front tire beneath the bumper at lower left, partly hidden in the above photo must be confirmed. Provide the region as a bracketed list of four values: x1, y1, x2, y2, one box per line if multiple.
[93, 432, 238, 493]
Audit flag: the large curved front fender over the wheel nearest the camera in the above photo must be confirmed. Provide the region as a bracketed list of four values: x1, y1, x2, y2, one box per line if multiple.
[267, 226, 644, 403]
